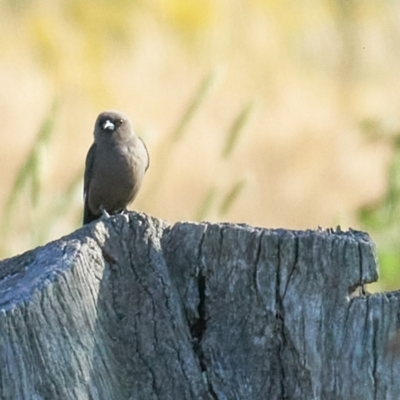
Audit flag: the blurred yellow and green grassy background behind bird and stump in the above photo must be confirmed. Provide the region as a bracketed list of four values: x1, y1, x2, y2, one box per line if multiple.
[0, 0, 400, 290]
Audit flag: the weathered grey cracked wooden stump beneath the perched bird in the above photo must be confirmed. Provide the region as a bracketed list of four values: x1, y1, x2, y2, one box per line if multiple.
[0, 213, 400, 400]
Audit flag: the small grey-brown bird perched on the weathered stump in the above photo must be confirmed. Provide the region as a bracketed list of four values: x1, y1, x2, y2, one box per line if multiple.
[83, 111, 149, 224]
